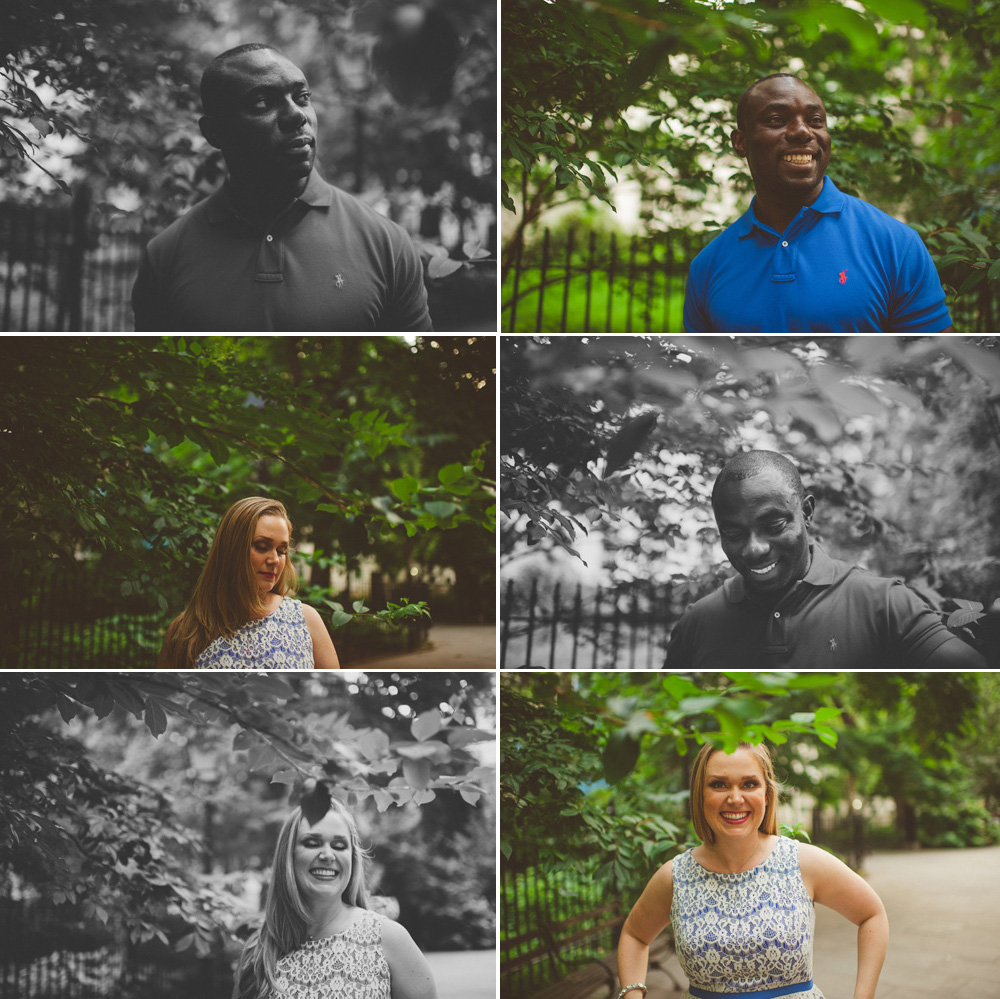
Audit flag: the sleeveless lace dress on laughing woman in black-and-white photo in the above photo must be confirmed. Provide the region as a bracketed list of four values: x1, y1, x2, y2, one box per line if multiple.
[275, 909, 391, 999]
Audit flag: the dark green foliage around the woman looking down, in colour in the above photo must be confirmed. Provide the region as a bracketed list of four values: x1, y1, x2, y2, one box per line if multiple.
[0, 337, 495, 652]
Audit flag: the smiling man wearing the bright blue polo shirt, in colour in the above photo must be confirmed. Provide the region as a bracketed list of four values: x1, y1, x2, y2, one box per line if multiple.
[684, 73, 954, 335]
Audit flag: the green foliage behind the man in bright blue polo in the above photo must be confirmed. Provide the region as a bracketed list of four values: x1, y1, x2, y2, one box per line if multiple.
[501, 0, 1000, 316]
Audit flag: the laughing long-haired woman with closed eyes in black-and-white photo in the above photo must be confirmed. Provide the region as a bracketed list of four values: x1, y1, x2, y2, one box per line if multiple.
[233, 798, 437, 999]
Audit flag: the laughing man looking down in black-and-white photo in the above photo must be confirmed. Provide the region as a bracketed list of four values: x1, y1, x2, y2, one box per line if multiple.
[665, 451, 986, 671]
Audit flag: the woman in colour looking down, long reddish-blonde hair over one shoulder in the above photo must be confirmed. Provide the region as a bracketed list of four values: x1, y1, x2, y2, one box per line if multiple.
[156, 496, 340, 669]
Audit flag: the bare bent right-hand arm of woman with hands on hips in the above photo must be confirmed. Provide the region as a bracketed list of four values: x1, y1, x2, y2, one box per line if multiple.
[799, 843, 889, 999]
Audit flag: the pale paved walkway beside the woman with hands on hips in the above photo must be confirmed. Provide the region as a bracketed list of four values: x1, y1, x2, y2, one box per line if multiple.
[579, 846, 1000, 999]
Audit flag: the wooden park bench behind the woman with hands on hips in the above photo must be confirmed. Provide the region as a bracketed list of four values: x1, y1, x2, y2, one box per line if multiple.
[502, 900, 683, 999]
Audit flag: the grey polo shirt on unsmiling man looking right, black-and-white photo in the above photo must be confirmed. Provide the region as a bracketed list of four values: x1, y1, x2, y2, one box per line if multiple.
[132, 170, 431, 333]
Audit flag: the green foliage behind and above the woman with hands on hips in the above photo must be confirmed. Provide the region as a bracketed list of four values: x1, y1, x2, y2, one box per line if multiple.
[500, 672, 996, 893]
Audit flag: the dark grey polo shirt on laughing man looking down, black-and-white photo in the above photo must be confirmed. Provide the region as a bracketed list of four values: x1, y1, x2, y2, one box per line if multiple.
[665, 544, 986, 671]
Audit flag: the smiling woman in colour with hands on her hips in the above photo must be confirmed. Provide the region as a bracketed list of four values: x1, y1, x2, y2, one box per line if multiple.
[618, 743, 889, 999]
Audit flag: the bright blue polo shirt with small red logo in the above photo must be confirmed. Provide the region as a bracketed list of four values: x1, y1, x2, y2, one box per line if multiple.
[684, 177, 951, 335]
